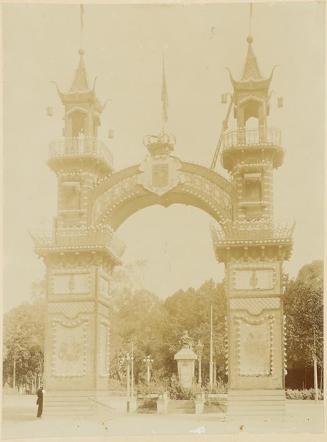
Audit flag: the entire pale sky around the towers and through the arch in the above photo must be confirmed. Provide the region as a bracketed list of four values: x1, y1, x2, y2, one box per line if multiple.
[3, 2, 324, 310]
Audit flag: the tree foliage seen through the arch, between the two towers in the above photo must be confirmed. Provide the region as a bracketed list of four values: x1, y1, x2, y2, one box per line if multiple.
[111, 262, 226, 381]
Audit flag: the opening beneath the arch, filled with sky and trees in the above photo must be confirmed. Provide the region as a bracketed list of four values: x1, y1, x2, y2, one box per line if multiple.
[111, 204, 226, 385]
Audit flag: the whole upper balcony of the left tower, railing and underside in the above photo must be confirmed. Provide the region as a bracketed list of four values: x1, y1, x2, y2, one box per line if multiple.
[48, 137, 113, 173]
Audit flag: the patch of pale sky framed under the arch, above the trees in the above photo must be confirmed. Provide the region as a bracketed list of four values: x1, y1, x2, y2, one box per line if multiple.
[116, 204, 224, 298]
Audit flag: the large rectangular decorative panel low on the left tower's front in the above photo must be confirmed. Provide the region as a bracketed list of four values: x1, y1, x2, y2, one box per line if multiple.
[52, 320, 88, 377]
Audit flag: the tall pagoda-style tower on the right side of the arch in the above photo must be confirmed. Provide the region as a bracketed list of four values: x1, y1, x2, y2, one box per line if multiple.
[213, 36, 292, 417]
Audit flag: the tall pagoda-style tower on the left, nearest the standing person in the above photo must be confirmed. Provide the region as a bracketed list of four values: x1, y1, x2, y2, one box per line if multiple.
[34, 49, 122, 414]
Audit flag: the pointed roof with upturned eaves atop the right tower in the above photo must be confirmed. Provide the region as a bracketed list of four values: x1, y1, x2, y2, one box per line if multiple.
[228, 35, 273, 90]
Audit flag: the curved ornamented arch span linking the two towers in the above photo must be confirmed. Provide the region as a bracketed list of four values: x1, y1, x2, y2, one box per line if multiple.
[88, 156, 232, 230]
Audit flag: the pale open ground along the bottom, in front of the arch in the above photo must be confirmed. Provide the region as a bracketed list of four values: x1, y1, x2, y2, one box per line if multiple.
[2, 395, 323, 439]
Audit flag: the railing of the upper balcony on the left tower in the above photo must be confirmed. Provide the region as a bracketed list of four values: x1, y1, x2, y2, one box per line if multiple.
[50, 137, 113, 168]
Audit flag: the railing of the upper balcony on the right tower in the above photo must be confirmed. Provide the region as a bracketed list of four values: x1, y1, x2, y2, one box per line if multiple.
[223, 127, 282, 149]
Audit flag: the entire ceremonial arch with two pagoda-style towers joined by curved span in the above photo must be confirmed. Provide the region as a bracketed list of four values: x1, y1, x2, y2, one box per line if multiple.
[34, 37, 292, 415]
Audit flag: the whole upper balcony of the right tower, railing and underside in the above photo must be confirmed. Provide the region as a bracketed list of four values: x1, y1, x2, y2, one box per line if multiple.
[222, 127, 284, 170]
